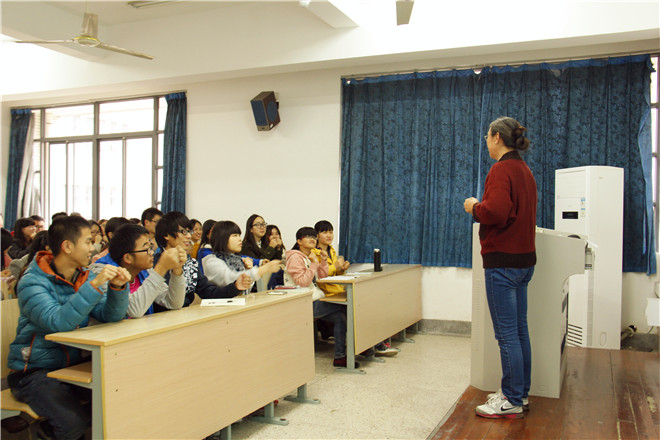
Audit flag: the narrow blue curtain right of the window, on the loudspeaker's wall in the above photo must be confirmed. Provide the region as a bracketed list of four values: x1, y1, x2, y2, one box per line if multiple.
[161, 93, 188, 212]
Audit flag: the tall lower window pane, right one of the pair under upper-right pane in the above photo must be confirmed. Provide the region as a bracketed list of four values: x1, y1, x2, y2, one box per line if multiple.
[126, 138, 153, 218]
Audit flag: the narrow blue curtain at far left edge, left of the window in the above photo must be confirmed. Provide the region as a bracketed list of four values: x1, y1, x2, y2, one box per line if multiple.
[4, 108, 32, 229]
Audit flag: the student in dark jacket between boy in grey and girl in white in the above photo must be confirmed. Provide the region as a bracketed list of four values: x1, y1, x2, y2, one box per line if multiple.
[154, 211, 252, 312]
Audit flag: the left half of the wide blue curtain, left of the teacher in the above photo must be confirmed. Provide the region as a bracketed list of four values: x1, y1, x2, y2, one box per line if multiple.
[340, 71, 482, 267]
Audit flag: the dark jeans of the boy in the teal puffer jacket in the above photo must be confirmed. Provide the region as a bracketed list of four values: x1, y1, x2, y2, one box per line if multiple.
[11, 370, 92, 440]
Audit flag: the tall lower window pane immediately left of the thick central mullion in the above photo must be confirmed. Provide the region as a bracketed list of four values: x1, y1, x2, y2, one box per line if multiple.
[69, 142, 93, 218]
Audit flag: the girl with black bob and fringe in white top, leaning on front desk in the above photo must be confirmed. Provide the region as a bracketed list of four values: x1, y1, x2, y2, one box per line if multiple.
[202, 220, 280, 288]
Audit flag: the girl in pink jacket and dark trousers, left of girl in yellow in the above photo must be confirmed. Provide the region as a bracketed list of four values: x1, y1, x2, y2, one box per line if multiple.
[284, 227, 360, 368]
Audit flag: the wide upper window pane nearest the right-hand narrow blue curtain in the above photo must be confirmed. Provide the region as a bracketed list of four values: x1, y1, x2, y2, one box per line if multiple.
[99, 98, 154, 134]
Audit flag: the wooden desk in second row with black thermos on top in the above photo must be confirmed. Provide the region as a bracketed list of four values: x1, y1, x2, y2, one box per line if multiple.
[318, 264, 422, 370]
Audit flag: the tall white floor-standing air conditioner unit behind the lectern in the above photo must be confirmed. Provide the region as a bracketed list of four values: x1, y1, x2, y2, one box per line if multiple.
[555, 166, 623, 349]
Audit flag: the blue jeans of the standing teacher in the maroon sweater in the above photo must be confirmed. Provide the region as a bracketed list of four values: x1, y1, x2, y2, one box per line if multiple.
[484, 266, 534, 406]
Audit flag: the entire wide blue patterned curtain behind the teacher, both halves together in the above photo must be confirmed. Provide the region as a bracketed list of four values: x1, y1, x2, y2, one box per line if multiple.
[340, 56, 655, 273]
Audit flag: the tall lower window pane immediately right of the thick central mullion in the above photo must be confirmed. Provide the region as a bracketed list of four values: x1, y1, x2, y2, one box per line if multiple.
[99, 140, 124, 219]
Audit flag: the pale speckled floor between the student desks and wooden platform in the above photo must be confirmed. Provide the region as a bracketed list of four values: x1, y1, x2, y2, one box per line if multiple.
[232, 335, 470, 439]
